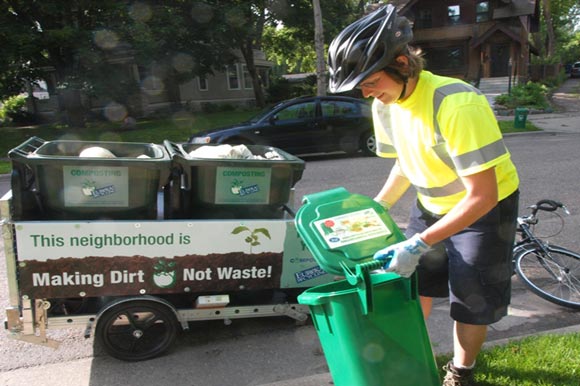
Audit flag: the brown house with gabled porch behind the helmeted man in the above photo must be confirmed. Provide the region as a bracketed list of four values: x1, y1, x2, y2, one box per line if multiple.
[391, 0, 540, 84]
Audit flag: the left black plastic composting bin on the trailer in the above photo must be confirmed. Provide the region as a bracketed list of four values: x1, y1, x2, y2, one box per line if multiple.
[8, 137, 171, 220]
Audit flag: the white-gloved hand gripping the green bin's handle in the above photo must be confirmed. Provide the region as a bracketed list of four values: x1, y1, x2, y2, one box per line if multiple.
[373, 234, 429, 277]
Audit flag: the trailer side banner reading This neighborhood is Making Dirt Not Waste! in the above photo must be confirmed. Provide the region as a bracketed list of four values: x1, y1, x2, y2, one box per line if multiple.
[16, 220, 328, 298]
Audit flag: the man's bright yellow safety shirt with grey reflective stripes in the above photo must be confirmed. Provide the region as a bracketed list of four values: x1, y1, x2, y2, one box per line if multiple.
[372, 71, 519, 214]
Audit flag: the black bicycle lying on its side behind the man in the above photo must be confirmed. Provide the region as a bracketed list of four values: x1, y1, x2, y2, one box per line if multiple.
[513, 199, 580, 309]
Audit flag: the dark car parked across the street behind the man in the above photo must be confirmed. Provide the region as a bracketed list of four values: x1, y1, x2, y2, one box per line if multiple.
[189, 96, 376, 155]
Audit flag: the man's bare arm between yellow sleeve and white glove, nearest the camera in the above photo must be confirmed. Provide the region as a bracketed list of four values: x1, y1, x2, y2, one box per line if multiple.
[419, 168, 498, 245]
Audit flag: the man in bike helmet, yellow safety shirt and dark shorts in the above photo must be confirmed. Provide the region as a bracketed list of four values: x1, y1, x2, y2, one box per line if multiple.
[328, 5, 519, 386]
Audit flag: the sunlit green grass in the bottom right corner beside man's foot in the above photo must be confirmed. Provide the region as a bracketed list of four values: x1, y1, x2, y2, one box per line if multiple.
[437, 333, 580, 386]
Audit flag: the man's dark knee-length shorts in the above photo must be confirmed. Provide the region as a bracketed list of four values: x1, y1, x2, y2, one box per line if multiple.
[405, 191, 519, 325]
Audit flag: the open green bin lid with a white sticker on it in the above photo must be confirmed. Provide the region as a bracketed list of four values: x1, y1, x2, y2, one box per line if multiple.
[295, 187, 405, 275]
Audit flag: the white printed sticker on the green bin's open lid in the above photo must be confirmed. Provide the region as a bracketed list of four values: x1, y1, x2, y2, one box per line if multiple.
[314, 208, 391, 249]
